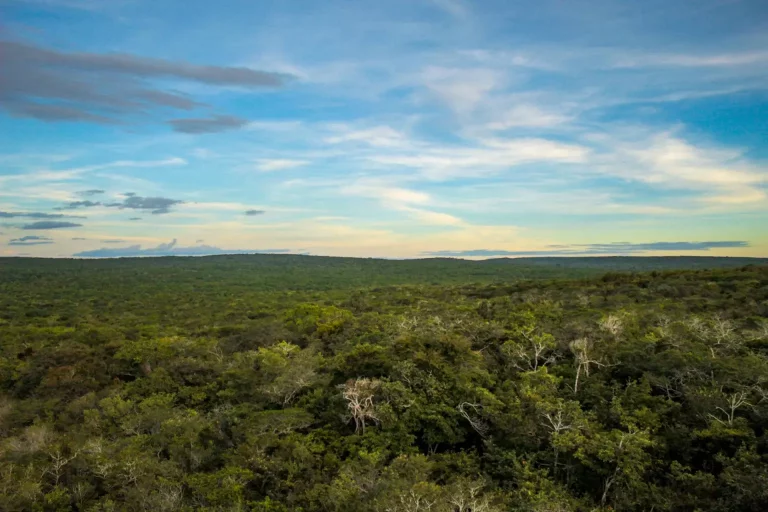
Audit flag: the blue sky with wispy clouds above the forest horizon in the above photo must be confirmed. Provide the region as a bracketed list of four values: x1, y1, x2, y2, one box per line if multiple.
[0, 0, 768, 259]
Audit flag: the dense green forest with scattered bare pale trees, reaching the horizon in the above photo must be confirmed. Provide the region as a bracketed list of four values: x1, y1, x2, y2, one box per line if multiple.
[0, 255, 768, 512]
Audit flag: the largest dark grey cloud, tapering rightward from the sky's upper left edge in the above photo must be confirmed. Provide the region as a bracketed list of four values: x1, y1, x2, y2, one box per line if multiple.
[0, 41, 292, 125]
